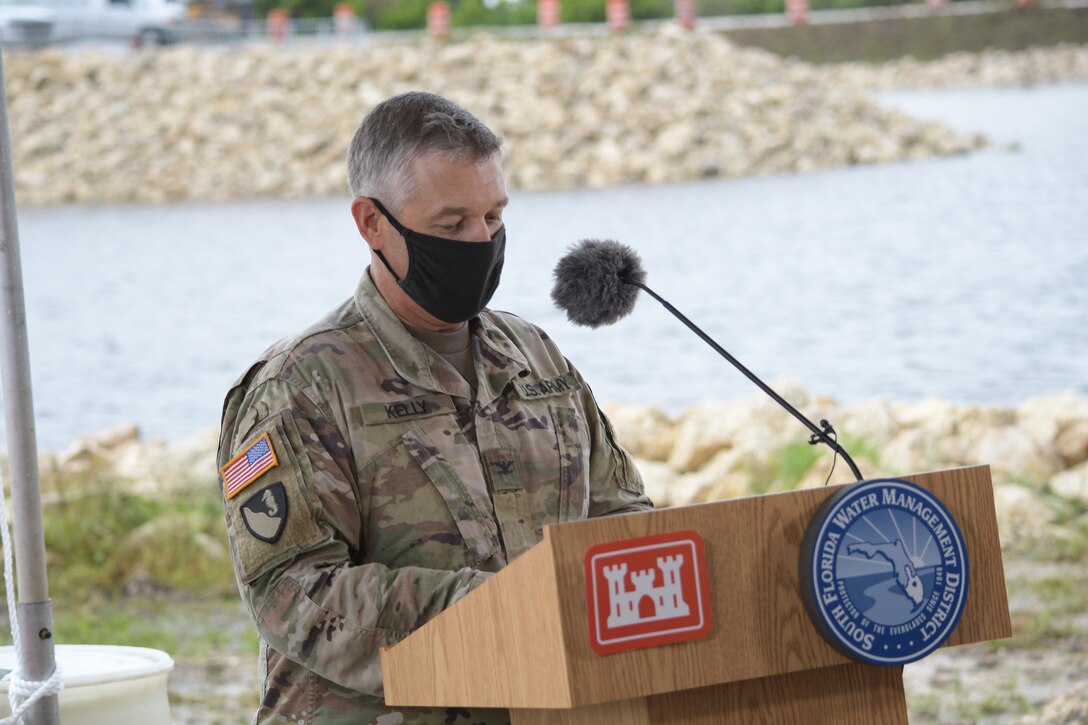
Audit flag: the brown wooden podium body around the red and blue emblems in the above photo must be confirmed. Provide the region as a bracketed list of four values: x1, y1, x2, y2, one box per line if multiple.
[382, 466, 1012, 725]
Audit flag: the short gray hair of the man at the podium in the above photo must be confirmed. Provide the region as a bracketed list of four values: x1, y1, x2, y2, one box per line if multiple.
[347, 91, 503, 211]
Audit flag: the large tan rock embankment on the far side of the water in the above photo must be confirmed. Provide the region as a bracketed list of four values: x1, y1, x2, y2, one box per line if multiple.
[4, 29, 1044, 205]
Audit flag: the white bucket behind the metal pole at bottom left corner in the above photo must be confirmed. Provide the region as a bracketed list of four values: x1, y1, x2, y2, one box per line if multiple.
[0, 644, 174, 725]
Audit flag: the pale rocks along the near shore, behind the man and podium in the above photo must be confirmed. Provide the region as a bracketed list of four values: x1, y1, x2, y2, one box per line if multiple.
[40, 389, 1088, 546]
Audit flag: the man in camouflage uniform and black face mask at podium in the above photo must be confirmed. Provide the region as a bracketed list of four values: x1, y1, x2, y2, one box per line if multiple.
[219, 94, 652, 725]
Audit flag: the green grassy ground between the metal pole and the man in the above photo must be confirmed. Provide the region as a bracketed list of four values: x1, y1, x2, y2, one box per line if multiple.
[0, 470, 258, 709]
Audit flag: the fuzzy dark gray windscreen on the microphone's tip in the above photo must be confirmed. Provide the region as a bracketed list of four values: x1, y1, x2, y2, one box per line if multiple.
[552, 239, 646, 328]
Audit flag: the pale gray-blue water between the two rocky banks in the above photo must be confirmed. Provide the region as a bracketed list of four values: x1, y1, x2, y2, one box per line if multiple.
[8, 85, 1088, 450]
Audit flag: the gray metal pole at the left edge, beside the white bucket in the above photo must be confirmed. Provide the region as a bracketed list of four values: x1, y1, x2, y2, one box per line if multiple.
[0, 47, 60, 725]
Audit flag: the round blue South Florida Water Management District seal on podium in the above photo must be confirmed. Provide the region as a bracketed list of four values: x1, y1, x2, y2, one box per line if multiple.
[800, 479, 968, 665]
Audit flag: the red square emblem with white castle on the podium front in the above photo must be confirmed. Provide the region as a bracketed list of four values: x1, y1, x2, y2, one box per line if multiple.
[585, 531, 710, 654]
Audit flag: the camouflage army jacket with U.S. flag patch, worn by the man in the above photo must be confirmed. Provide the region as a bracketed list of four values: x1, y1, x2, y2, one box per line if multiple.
[219, 273, 652, 725]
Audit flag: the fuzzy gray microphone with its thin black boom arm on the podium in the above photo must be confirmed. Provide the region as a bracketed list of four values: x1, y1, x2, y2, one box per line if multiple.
[552, 239, 863, 481]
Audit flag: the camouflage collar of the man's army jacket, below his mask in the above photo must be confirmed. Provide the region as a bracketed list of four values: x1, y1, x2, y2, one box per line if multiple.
[355, 268, 529, 402]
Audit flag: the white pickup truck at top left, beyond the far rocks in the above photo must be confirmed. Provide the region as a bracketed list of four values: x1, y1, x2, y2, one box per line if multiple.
[39, 0, 185, 46]
